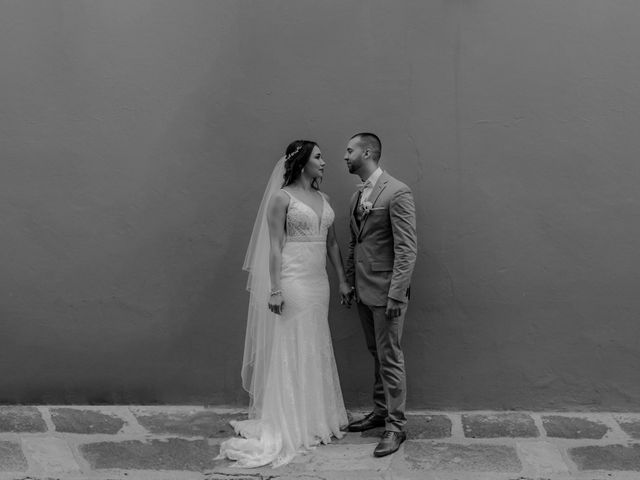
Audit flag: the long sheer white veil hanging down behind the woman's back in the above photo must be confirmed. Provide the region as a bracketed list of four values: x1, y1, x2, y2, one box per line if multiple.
[242, 157, 285, 418]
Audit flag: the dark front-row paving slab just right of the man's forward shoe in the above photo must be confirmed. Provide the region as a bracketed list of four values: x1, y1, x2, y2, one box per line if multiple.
[404, 441, 522, 473]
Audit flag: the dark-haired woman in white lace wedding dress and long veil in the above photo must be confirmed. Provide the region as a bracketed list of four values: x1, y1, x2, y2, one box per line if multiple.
[219, 140, 352, 467]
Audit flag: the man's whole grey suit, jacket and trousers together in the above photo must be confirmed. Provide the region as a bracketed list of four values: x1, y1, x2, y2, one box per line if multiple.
[346, 172, 417, 431]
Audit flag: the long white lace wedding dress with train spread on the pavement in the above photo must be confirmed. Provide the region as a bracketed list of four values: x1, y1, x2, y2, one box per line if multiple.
[220, 192, 347, 467]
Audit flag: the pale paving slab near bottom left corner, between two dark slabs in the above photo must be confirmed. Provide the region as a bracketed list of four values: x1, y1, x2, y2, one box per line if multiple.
[22, 437, 80, 475]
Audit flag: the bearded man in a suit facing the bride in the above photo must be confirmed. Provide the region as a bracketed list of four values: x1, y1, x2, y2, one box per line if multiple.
[344, 133, 417, 457]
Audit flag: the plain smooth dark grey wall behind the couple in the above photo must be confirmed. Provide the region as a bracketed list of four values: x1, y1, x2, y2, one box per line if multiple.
[0, 0, 640, 410]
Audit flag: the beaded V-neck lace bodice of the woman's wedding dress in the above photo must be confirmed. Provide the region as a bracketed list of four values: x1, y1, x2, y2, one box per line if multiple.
[284, 190, 335, 242]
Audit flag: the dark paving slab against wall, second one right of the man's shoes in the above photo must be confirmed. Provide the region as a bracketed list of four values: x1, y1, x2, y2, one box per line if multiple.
[462, 412, 539, 438]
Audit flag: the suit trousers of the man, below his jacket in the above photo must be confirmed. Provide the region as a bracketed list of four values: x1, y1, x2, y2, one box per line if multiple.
[358, 302, 407, 432]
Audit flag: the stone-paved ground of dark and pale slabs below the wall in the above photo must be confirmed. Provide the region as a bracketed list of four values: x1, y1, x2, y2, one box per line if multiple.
[0, 406, 640, 480]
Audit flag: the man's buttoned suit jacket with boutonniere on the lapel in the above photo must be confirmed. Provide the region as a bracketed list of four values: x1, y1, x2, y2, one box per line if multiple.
[345, 172, 418, 306]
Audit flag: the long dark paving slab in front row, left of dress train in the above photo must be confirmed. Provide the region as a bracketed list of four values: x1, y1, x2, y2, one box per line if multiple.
[79, 438, 221, 472]
